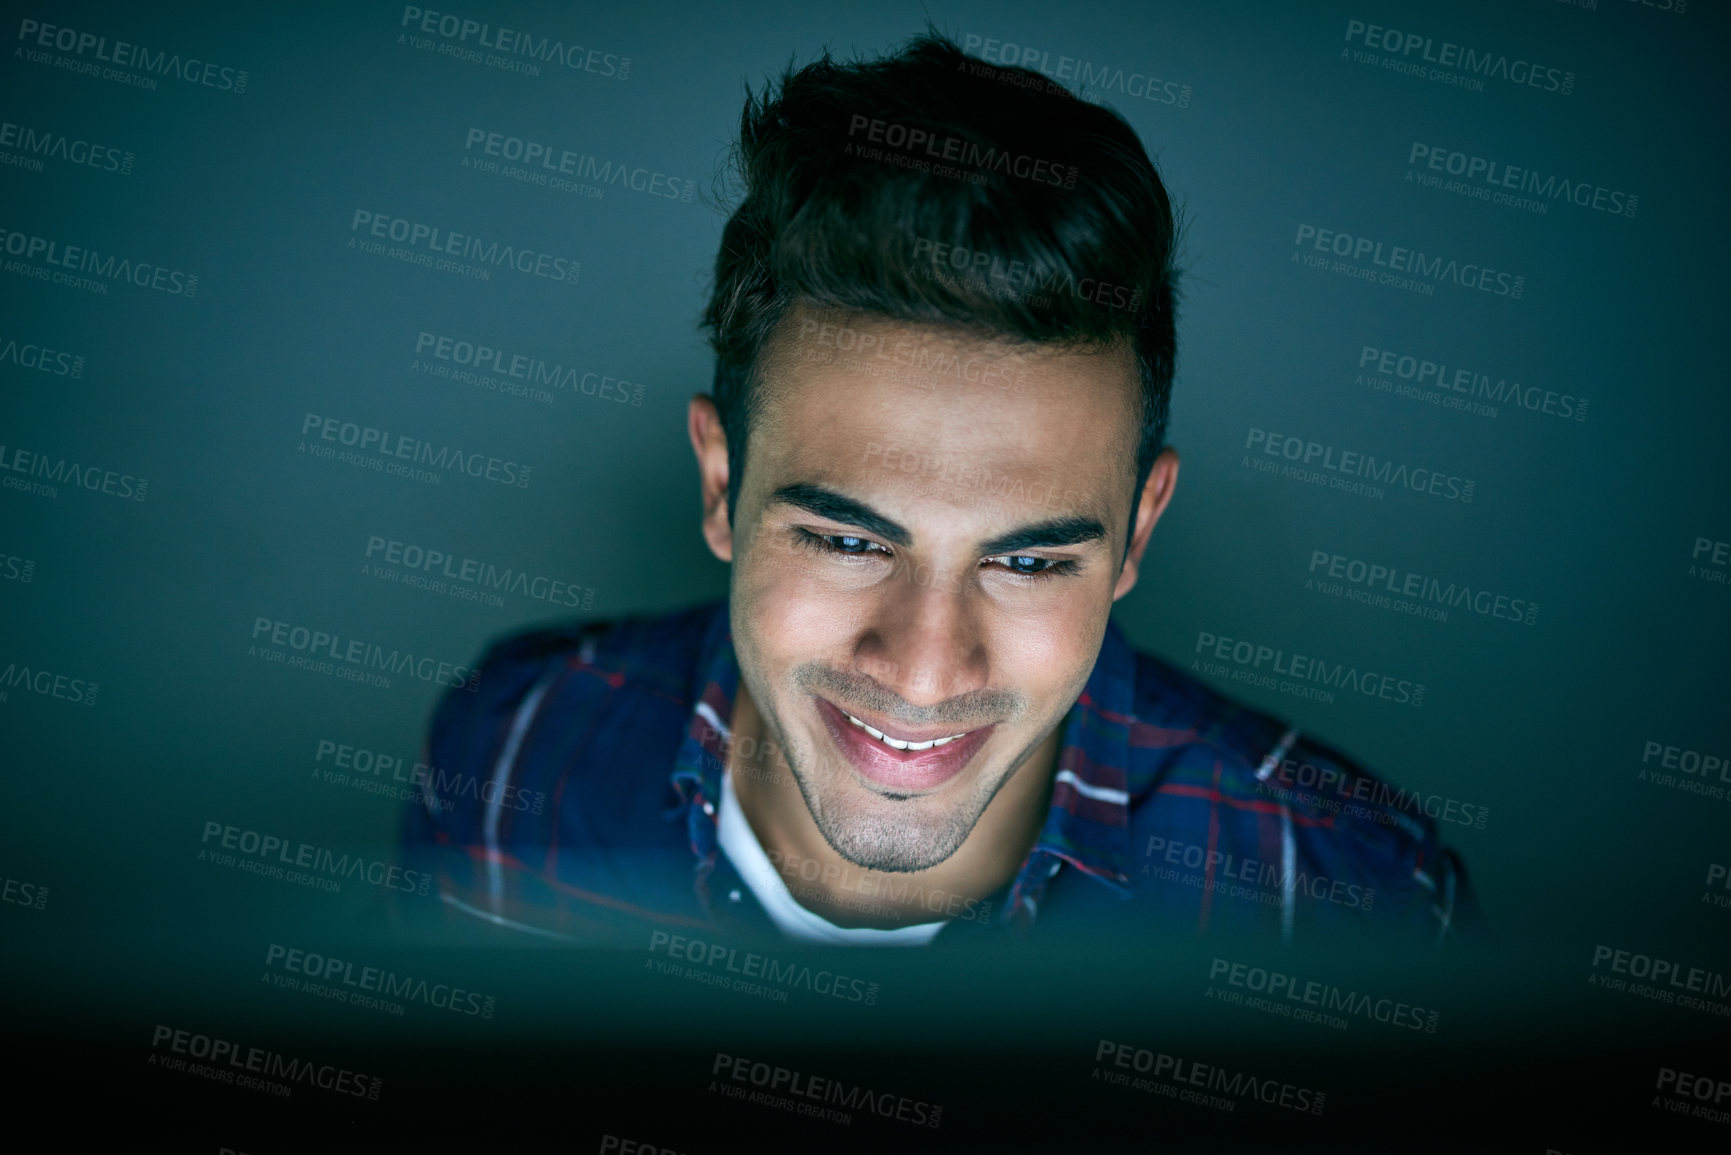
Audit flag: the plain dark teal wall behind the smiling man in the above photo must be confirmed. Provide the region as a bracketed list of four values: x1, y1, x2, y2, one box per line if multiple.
[0, 0, 1731, 1150]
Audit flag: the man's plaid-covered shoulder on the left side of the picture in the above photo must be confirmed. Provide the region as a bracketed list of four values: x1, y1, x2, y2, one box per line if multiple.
[400, 604, 727, 940]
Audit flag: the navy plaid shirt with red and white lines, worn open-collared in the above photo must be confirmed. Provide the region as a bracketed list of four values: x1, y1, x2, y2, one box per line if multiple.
[403, 603, 1478, 945]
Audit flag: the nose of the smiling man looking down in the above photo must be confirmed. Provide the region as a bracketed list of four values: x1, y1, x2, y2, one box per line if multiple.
[853, 566, 992, 707]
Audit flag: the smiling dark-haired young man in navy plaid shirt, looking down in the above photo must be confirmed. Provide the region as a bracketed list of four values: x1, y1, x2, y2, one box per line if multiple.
[405, 36, 1471, 945]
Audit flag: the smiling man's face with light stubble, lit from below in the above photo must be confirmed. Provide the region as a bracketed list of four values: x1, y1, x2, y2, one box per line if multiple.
[709, 303, 1170, 871]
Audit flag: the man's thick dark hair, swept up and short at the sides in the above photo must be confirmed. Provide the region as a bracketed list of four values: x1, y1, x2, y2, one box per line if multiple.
[703, 33, 1177, 543]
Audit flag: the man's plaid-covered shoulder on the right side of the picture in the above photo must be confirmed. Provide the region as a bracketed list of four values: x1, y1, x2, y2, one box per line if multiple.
[1127, 637, 1468, 940]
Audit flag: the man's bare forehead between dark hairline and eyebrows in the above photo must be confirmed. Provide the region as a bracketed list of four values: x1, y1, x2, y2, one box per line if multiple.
[746, 308, 1141, 514]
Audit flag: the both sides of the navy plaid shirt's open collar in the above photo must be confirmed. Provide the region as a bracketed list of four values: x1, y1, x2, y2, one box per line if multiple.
[672, 603, 1136, 890]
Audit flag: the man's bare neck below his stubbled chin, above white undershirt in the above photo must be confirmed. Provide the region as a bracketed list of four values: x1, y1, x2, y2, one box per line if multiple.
[727, 681, 1059, 928]
